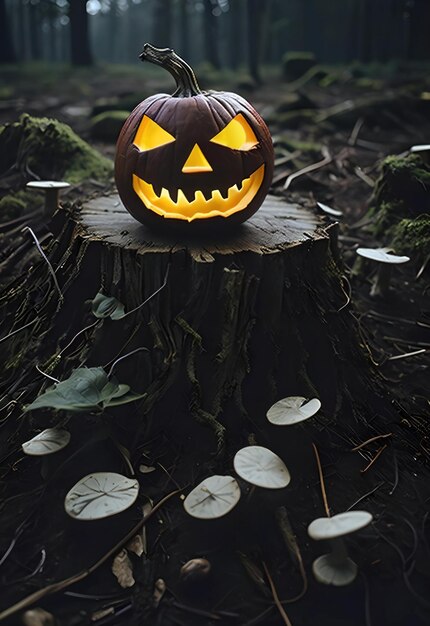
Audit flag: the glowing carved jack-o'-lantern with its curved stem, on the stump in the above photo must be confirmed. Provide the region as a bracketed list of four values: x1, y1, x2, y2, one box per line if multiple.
[115, 44, 274, 231]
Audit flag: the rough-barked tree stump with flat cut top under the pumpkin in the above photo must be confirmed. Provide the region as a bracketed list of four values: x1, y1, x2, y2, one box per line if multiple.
[2, 195, 367, 451]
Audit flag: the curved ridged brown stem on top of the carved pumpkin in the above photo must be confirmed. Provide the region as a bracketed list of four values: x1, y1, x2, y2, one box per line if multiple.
[139, 43, 202, 98]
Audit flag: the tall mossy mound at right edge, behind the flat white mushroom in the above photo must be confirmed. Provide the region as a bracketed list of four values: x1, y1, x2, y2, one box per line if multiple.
[368, 154, 430, 235]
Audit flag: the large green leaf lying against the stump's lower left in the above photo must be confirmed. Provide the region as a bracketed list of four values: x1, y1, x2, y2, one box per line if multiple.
[25, 367, 142, 412]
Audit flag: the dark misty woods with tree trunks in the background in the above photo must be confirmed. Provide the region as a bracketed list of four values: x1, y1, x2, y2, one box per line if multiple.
[0, 0, 430, 71]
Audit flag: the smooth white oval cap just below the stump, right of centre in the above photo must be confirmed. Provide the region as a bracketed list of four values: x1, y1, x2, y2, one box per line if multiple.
[233, 446, 291, 489]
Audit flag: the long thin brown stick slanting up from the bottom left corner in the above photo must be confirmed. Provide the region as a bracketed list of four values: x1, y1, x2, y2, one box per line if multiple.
[0, 489, 180, 621]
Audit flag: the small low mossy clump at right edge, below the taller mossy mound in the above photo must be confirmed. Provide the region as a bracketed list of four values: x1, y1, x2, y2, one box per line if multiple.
[390, 214, 430, 263]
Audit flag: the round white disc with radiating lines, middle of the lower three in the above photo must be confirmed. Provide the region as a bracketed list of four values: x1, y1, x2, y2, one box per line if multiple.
[184, 475, 240, 519]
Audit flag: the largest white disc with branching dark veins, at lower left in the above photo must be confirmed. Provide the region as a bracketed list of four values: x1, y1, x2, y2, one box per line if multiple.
[64, 472, 139, 521]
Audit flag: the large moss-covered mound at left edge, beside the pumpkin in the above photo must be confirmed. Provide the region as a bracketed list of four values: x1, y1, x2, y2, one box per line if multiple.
[0, 114, 112, 183]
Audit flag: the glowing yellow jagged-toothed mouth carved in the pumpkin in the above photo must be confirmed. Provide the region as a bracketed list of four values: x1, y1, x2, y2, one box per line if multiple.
[133, 164, 264, 222]
